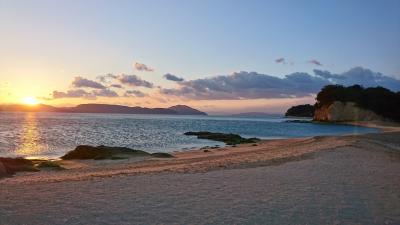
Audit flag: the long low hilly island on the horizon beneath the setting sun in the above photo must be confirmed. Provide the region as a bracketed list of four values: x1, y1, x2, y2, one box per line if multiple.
[0, 104, 207, 115]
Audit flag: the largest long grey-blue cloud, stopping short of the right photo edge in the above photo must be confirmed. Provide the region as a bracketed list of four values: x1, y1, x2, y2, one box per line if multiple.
[161, 72, 327, 100]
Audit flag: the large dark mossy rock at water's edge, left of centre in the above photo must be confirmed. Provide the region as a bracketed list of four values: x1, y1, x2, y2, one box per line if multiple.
[61, 145, 150, 159]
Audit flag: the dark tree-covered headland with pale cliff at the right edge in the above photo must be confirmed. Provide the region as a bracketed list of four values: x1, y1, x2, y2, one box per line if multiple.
[285, 85, 400, 122]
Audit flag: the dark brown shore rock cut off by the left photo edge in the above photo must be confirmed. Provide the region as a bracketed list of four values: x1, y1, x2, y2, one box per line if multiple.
[0, 157, 38, 177]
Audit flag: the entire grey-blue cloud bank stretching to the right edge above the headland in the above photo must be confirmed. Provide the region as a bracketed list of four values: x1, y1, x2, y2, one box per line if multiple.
[159, 67, 400, 100]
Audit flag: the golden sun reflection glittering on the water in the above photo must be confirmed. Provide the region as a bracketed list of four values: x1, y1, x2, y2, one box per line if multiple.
[16, 113, 40, 157]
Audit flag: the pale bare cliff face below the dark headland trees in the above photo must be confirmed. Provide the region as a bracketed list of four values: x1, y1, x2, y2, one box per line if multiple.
[314, 101, 384, 122]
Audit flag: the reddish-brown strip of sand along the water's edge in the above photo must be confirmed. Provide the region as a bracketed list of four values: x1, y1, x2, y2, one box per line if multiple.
[0, 122, 400, 184]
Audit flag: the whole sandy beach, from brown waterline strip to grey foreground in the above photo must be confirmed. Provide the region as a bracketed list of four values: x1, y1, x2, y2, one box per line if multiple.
[0, 124, 400, 224]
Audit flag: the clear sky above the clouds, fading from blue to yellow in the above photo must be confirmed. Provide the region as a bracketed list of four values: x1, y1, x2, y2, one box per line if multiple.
[0, 0, 400, 112]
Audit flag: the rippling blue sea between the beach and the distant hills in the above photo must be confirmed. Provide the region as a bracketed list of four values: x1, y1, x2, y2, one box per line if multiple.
[0, 112, 376, 158]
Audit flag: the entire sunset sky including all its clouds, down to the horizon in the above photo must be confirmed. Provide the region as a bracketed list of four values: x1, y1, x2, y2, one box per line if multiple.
[0, 0, 400, 114]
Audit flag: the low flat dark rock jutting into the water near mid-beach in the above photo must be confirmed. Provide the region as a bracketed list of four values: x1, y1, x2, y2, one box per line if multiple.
[184, 131, 260, 145]
